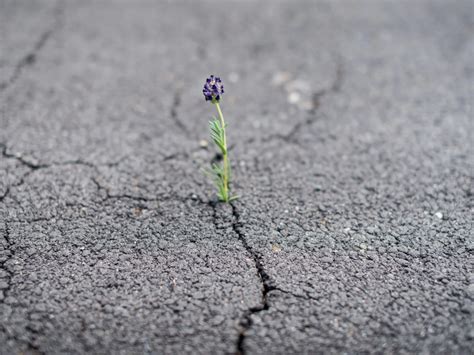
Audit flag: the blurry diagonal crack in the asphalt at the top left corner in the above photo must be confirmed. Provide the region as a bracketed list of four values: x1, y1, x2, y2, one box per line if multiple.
[0, 2, 62, 94]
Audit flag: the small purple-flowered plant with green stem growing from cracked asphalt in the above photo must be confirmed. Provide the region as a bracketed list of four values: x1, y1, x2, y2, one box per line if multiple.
[202, 75, 237, 202]
